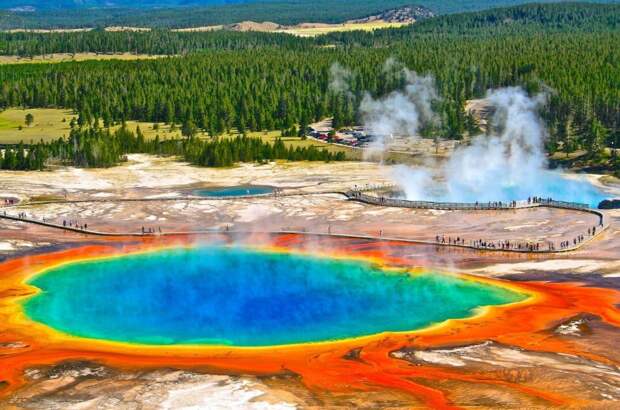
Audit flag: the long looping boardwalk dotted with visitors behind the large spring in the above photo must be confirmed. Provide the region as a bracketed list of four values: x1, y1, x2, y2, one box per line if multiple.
[0, 185, 608, 253]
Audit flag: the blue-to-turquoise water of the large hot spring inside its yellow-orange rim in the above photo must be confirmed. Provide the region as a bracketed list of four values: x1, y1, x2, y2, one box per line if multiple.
[24, 247, 525, 346]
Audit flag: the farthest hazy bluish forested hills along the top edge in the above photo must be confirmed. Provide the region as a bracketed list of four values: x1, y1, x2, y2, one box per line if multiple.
[0, 0, 618, 30]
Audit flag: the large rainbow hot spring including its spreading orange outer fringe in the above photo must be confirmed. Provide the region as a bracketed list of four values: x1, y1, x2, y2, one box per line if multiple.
[0, 229, 620, 408]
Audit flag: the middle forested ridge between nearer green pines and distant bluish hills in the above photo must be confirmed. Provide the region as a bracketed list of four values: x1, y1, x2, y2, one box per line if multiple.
[0, 3, 620, 53]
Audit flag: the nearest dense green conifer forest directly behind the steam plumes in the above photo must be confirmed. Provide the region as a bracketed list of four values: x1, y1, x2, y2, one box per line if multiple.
[0, 33, 620, 146]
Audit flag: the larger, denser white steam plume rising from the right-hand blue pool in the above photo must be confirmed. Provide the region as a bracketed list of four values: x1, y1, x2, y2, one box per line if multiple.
[394, 87, 547, 202]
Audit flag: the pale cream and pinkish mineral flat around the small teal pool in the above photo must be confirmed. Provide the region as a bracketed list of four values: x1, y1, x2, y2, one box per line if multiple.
[0, 155, 617, 270]
